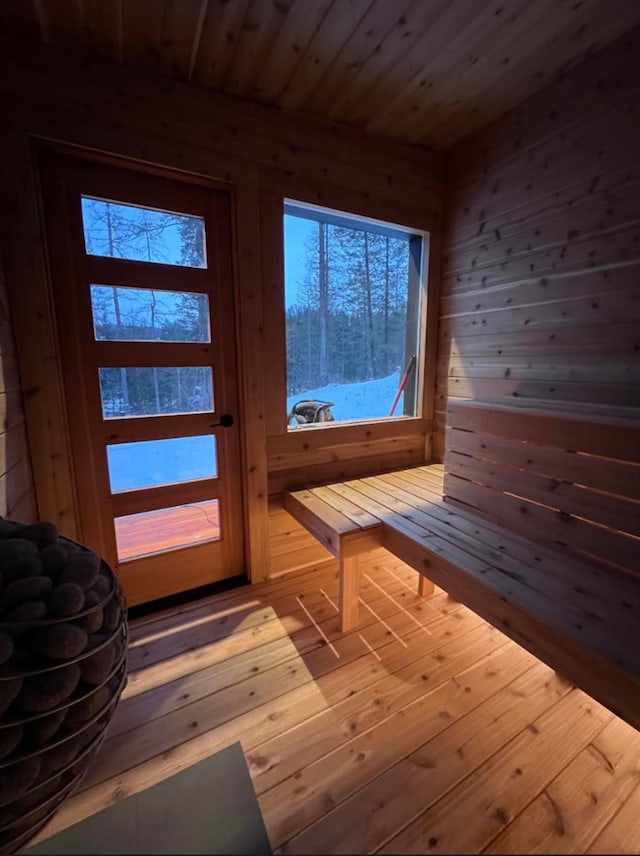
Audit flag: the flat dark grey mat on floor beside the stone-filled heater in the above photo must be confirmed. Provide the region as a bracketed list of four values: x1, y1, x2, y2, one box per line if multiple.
[24, 743, 271, 856]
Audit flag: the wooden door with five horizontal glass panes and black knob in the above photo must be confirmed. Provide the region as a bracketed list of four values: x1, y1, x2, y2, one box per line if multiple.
[41, 153, 244, 605]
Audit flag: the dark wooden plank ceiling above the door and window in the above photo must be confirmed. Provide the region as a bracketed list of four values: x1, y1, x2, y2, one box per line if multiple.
[0, 0, 640, 149]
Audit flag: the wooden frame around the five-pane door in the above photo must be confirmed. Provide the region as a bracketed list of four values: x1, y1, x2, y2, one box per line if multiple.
[26, 138, 260, 596]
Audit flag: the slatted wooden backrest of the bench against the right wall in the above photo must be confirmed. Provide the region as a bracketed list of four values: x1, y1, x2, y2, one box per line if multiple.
[444, 400, 640, 572]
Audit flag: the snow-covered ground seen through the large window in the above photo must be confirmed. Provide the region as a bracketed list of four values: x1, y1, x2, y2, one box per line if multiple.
[287, 372, 403, 424]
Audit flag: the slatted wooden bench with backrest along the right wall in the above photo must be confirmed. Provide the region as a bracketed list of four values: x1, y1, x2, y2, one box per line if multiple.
[286, 400, 640, 729]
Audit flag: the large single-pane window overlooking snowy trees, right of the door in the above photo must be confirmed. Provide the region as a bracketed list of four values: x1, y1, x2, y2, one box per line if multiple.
[284, 201, 425, 430]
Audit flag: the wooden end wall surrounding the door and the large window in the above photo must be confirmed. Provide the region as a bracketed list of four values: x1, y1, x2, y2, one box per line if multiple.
[0, 39, 444, 579]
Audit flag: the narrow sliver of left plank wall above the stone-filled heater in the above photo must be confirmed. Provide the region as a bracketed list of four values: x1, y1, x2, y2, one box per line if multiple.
[0, 249, 36, 523]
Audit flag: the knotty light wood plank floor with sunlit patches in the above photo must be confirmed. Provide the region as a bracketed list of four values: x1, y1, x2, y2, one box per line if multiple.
[32, 551, 640, 853]
